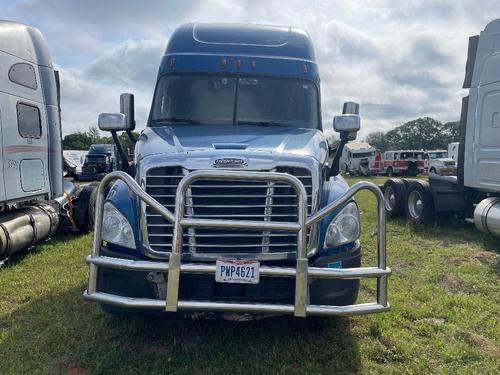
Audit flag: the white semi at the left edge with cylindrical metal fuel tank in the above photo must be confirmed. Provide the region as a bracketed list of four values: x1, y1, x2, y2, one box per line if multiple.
[0, 21, 95, 260]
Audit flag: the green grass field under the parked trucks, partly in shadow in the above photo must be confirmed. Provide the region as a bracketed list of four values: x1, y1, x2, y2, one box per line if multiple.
[0, 179, 500, 374]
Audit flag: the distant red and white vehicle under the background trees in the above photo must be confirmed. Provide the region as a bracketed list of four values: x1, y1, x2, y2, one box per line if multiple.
[375, 150, 425, 176]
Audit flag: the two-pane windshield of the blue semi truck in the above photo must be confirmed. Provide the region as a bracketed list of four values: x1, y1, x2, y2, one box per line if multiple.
[151, 74, 319, 129]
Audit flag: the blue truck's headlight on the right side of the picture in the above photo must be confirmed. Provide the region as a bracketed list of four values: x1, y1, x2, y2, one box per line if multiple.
[323, 202, 359, 249]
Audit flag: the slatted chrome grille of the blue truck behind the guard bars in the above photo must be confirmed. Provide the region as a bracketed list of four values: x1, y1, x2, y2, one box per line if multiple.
[146, 166, 313, 254]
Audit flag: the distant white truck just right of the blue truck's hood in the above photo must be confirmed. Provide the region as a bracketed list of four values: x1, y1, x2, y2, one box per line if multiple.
[340, 142, 377, 176]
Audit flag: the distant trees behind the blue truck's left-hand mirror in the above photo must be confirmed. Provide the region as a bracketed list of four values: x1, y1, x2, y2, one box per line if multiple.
[63, 126, 139, 154]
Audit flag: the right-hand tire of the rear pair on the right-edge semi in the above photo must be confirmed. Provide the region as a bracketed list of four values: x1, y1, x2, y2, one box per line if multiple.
[405, 180, 435, 225]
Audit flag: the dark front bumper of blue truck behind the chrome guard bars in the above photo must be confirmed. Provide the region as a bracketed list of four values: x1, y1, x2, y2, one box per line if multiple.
[87, 241, 361, 306]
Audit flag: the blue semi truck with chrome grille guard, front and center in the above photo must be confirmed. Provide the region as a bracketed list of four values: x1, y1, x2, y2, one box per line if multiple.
[84, 24, 391, 317]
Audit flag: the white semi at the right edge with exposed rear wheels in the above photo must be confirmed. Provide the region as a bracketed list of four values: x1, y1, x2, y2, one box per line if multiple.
[384, 19, 500, 237]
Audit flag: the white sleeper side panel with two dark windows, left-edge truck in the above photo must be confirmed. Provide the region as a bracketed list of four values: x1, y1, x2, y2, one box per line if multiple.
[0, 52, 49, 201]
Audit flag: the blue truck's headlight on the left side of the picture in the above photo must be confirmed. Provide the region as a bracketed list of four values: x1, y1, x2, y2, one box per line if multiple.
[101, 202, 135, 249]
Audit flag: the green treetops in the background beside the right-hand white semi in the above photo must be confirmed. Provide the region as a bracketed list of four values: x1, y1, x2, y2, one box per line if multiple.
[365, 117, 460, 152]
